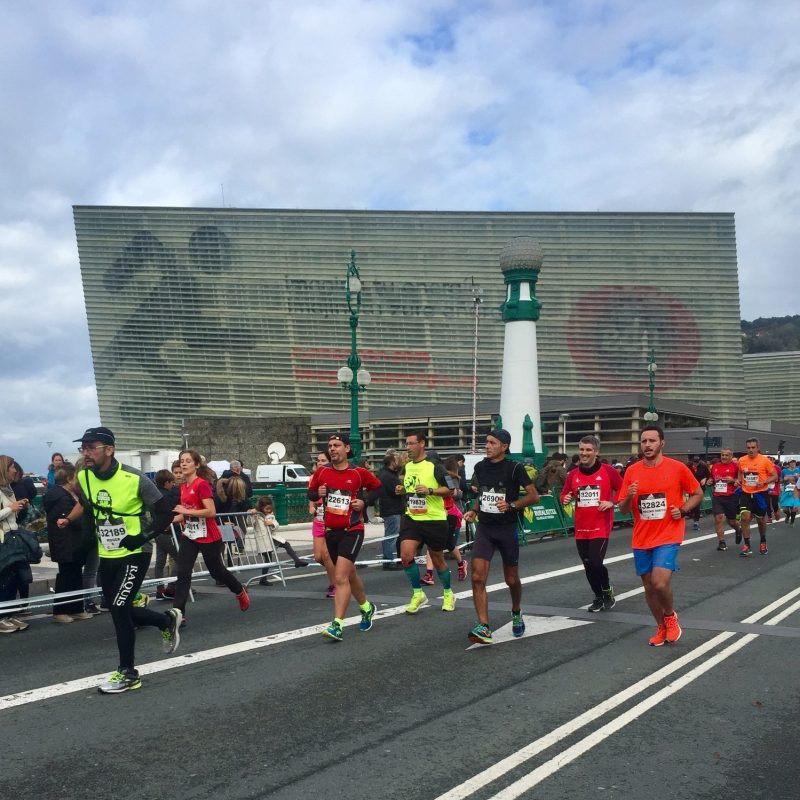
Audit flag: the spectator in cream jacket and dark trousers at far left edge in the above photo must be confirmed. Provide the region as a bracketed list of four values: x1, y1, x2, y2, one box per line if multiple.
[0, 456, 33, 633]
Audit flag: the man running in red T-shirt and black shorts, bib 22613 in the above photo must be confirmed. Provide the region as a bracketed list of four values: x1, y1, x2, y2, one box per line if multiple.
[308, 433, 381, 642]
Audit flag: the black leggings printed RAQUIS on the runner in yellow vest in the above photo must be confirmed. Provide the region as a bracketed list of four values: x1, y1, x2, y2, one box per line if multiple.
[100, 553, 172, 672]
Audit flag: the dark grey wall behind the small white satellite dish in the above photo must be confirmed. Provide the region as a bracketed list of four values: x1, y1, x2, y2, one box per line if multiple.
[186, 415, 311, 472]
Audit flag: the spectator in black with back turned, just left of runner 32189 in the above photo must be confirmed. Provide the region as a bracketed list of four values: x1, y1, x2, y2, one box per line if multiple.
[43, 464, 93, 624]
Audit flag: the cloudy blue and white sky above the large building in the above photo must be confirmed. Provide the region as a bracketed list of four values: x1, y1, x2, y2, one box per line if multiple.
[0, 0, 800, 471]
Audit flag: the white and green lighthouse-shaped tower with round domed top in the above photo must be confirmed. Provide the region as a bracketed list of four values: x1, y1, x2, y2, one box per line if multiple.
[500, 236, 542, 454]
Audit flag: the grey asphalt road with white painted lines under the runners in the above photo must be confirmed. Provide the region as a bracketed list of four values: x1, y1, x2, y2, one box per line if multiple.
[0, 521, 800, 800]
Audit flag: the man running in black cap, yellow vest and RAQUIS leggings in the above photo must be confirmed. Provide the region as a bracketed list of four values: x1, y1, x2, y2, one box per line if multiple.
[75, 427, 182, 694]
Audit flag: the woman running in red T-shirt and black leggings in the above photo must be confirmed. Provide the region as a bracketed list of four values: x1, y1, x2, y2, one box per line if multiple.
[173, 450, 250, 616]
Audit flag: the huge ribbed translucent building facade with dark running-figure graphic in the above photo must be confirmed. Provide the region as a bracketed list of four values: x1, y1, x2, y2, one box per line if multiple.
[74, 206, 744, 447]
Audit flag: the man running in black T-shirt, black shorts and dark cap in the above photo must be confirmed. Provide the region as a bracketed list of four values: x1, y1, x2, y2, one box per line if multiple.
[464, 428, 539, 644]
